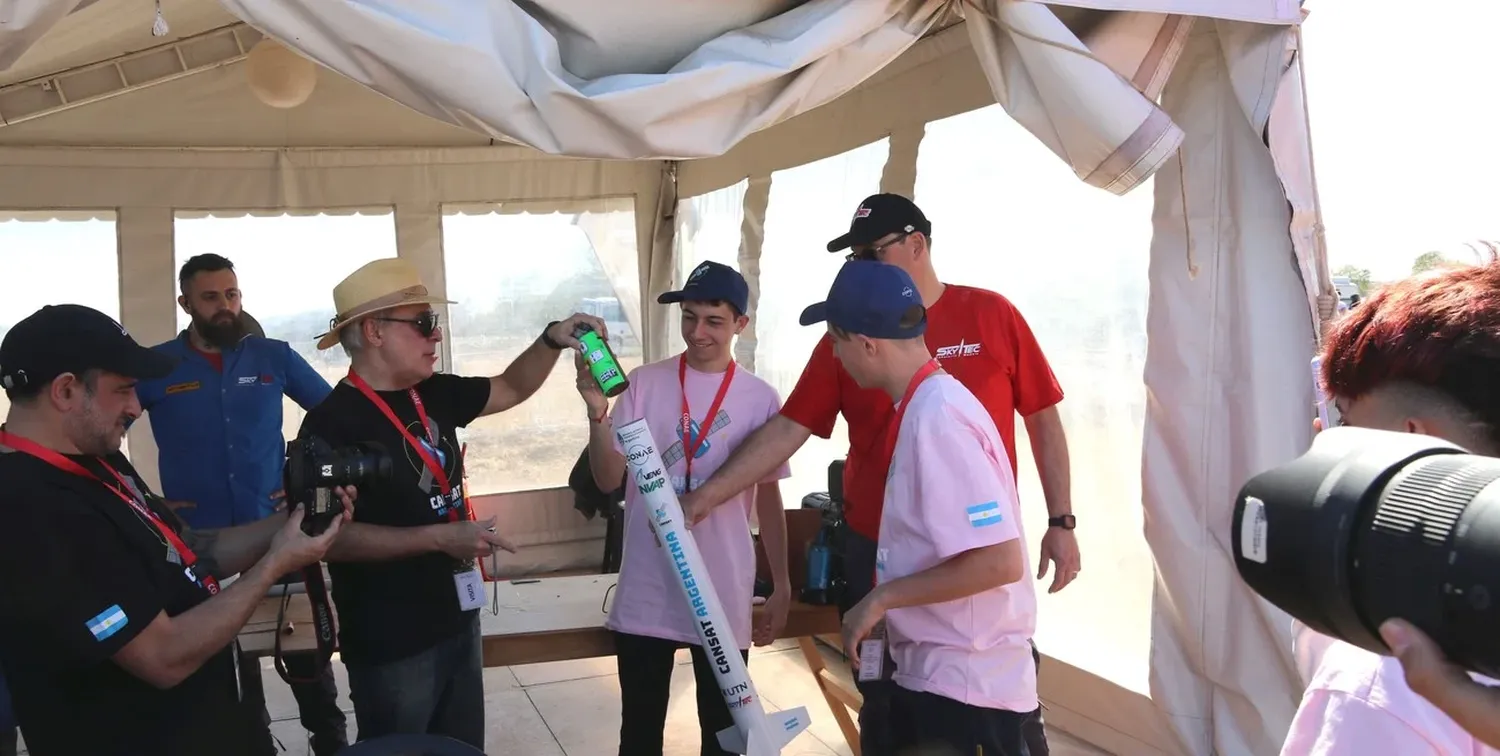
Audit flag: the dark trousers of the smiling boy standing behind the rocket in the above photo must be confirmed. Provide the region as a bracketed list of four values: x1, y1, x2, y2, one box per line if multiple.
[615, 633, 750, 756]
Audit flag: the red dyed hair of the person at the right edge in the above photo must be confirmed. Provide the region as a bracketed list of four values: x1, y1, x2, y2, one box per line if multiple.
[1323, 263, 1500, 441]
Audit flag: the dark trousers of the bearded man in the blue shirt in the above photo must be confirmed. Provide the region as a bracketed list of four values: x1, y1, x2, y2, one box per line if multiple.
[240, 653, 350, 756]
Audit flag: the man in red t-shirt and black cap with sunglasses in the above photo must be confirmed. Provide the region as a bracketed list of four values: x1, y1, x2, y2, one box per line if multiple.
[681, 194, 1080, 756]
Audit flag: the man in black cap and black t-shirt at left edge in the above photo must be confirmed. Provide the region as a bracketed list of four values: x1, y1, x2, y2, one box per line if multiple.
[0, 305, 353, 756]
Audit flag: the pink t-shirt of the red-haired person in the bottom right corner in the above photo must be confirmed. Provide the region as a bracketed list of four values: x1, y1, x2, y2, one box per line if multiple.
[1281, 641, 1500, 756]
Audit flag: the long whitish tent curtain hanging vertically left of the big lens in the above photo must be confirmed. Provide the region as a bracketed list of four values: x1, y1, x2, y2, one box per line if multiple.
[1142, 21, 1314, 755]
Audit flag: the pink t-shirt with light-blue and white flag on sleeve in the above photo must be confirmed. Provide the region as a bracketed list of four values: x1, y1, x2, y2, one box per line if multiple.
[876, 374, 1037, 713]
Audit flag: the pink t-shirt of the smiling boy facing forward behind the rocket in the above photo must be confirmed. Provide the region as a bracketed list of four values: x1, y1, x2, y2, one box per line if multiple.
[605, 357, 792, 648]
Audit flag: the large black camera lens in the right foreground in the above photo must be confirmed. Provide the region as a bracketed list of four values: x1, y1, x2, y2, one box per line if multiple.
[1230, 428, 1500, 678]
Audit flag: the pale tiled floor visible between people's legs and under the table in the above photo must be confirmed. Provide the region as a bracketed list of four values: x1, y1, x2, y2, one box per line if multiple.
[14, 641, 1107, 756]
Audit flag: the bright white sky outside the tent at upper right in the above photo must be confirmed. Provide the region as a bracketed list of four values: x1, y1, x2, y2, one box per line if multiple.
[1304, 0, 1500, 281]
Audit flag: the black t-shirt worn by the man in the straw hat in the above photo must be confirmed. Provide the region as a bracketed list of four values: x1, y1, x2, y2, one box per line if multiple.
[299, 374, 489, 665]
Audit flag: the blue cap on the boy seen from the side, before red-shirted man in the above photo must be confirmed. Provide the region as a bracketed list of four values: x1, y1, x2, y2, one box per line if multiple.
[801, 260, 927, 339]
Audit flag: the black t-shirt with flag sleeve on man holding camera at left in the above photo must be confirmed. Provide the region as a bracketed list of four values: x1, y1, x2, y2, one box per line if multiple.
[0, 450, 252, 756]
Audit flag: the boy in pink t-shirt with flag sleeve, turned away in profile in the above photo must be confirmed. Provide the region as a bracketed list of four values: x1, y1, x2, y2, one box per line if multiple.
[801, 260, 1038, 755]
